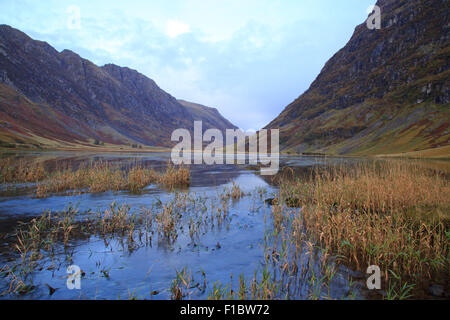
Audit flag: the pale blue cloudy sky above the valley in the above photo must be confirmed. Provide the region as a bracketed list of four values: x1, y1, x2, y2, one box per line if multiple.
[0, 0, 375, 130]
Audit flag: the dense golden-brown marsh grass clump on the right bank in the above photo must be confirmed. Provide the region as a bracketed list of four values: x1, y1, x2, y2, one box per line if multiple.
[274, 161, 450, 298]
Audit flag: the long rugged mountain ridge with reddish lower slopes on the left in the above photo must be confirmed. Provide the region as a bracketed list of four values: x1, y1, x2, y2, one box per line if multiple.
[0, 25, 237, 147]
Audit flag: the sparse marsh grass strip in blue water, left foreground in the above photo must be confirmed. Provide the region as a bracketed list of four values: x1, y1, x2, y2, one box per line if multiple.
[0, 191, 237, 295]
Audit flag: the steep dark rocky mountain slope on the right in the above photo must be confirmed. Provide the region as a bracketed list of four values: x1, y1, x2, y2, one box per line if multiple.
[267, 0, 450, 157]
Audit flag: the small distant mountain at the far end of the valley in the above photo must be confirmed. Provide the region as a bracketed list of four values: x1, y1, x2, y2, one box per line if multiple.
[178, 99, 238, 132]
